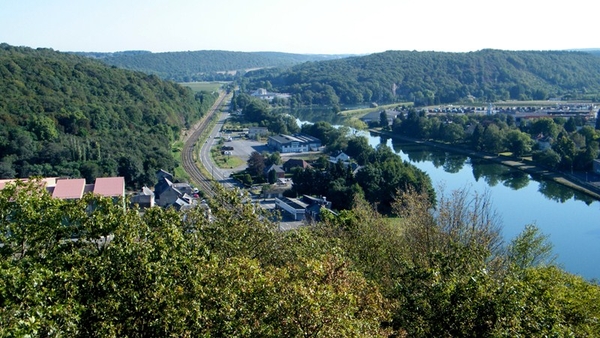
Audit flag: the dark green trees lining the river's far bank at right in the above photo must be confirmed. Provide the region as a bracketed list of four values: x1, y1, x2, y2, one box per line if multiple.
[394, 109, 600, 171]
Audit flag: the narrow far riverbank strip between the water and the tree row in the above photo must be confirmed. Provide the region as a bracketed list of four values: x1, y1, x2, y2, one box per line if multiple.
[369, 129, 600, 201]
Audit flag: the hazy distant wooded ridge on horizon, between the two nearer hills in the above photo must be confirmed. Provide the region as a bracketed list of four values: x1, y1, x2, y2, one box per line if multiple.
[79, 50, 352, 82]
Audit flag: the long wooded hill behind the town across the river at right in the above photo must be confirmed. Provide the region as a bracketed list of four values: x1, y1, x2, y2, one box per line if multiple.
[240, 50, 600, 105]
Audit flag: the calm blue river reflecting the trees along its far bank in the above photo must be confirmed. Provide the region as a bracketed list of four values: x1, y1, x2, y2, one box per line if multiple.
[292, 109, 600, 280]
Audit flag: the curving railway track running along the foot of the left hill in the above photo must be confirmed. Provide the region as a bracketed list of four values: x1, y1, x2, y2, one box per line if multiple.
[181, 92, 226, 198]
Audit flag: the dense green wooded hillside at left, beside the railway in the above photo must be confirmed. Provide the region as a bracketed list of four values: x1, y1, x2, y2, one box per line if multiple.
[0, 44, 215, 186]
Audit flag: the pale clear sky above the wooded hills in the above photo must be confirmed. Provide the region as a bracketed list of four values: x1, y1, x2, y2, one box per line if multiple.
[0, 0, 600, 54]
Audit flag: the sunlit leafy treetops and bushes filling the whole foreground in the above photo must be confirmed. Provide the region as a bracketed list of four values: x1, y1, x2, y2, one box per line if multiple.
[0, 183, 600, 337]
